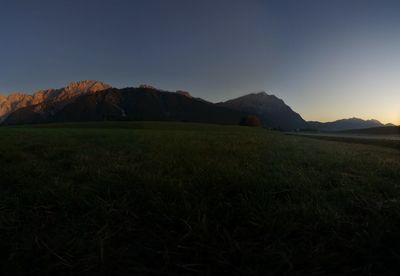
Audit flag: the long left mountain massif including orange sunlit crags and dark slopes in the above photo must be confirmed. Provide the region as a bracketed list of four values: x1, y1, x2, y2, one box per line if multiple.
[0, 81, 244, 125]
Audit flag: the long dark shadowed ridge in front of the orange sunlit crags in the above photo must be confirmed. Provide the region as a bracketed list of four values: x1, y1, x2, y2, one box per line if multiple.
[4, 86, 244, 124]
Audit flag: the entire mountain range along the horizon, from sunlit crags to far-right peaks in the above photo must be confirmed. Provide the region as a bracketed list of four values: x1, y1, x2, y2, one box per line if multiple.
[0, 81, 394, 131]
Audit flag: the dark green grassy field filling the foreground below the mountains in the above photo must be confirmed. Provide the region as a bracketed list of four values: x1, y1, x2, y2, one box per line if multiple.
[0, 122, 400, 275]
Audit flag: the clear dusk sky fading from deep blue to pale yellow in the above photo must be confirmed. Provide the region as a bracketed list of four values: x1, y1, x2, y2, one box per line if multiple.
[0, 0, 400, 124]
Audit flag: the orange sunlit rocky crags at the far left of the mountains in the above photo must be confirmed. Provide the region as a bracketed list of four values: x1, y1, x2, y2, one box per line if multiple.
[0, 80, 111, 122]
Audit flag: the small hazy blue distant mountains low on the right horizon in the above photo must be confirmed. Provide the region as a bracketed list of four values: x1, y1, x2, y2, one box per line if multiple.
[307, 118, 385, 131]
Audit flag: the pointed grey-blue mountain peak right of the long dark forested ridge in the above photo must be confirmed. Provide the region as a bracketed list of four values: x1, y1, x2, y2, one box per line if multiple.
[218, 92, 308, 130]
